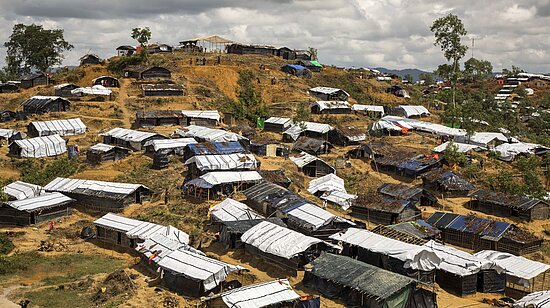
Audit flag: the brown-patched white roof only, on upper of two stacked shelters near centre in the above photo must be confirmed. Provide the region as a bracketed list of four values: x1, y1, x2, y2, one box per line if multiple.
[185, 153, 260, 171]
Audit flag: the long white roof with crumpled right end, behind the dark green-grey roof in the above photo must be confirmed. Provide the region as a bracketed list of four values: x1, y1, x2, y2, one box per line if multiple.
[329, 228, 442, 271]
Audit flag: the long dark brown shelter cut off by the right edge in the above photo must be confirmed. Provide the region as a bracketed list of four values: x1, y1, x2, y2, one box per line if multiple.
[468, 189, 550, 220]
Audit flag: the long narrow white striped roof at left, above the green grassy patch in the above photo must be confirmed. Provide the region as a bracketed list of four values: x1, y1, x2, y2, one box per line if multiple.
[44, 178, 147, 195]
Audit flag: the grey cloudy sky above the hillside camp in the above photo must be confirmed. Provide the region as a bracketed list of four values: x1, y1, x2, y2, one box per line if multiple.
[0, 0, 550, 73]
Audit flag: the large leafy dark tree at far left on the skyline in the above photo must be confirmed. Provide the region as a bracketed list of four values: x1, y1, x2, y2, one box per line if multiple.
[4, 24, 74, 76]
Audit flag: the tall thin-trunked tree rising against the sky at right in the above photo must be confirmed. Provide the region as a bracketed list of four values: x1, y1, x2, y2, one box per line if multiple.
[430, 14, 468, 105]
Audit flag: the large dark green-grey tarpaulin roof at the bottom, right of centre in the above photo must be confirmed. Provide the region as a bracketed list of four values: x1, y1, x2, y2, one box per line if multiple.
[306, 253, 416, 300]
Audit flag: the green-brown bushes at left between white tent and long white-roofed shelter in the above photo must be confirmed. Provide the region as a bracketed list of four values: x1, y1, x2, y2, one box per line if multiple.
[13, 158, 82, 186]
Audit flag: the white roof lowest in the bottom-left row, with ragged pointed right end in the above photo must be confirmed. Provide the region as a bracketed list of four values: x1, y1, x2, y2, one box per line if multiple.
[158, 250, 244, 291]
